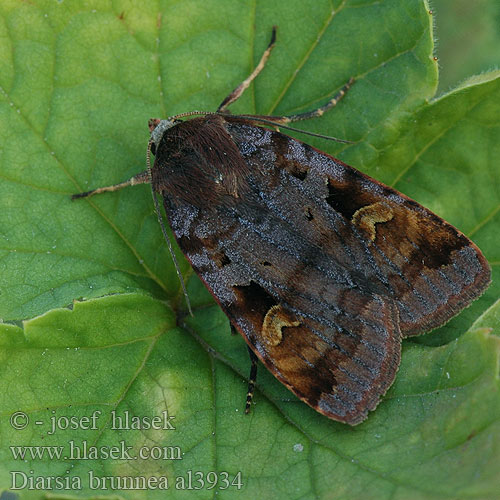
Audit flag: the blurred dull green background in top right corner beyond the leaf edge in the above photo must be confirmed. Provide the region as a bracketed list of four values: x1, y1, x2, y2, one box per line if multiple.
[430, 0, 500, 95]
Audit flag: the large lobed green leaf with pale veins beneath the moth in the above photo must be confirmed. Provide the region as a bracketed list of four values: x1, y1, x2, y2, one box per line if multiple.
[0, 0, 500, 499]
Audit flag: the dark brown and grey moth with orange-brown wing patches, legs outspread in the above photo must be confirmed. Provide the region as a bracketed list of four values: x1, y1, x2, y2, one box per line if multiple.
[73, 29, 490, 425]
